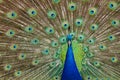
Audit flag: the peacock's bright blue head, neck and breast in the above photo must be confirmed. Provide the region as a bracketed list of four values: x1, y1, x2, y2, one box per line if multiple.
[61, 35, 82, 80]
